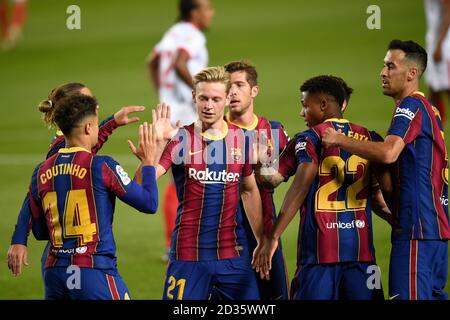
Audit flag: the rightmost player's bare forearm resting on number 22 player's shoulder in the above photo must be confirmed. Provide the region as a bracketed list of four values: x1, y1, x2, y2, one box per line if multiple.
[322, 128, 405, 164]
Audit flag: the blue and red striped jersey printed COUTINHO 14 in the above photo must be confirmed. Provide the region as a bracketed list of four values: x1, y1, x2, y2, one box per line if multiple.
[29, 148, 158, 269]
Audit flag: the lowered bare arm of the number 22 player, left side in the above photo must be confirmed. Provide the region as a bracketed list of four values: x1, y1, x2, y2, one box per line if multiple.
[263, 162, 318, 276]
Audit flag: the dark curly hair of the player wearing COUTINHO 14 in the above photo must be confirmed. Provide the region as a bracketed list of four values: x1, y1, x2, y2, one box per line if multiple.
[54, 94, 97, 136]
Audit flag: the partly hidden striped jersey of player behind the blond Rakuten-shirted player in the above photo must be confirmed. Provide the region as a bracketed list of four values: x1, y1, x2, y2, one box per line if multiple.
[226, 115, 289, 236]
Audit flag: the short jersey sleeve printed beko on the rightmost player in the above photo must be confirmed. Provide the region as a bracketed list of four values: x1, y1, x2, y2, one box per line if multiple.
[388, 97, 422, 144]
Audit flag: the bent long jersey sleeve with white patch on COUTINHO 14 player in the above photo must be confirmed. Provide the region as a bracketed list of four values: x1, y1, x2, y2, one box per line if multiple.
[101, 157, 158, 213]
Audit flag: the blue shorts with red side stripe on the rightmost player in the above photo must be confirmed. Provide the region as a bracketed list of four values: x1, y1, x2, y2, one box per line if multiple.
[389, 240, 448, 300]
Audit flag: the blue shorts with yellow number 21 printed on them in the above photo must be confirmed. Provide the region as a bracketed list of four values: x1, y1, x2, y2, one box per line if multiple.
[163, 256, 259, 300]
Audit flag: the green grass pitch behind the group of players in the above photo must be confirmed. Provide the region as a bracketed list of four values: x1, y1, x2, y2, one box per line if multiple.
[0, 0, 450, 299]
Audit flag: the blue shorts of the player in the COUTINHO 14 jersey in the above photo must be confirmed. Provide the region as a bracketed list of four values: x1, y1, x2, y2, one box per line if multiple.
[44, 266, 130, 300]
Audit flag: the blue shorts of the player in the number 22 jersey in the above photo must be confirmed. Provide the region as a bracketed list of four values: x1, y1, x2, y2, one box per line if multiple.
[291, 262, 383, 300]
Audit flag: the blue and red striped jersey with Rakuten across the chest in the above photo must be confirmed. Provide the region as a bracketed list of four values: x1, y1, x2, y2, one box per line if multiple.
[160, 123, 253, 261]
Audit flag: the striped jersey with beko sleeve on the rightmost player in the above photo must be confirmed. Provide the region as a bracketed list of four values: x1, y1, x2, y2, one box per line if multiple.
[388, 92, 450, 240]
